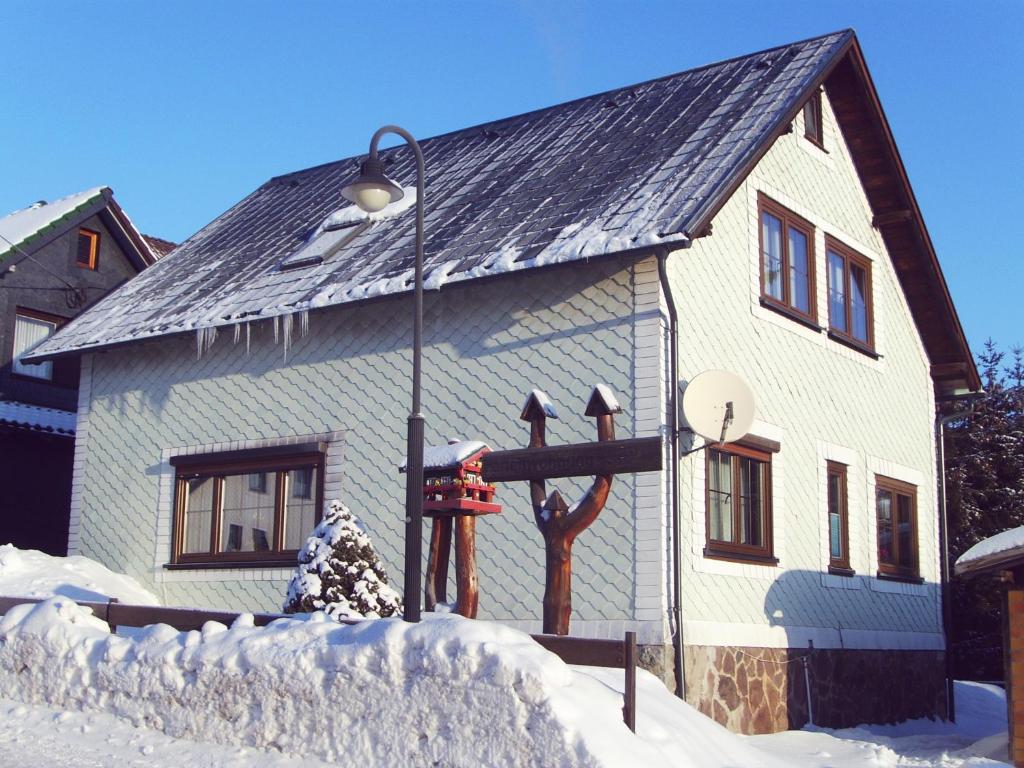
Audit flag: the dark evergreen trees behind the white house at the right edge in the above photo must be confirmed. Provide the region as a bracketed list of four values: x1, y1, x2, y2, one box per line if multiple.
[946, 341, 1024, 679]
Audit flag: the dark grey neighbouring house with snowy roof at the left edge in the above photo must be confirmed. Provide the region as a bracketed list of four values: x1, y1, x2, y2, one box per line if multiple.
[0, 187, 157, 555]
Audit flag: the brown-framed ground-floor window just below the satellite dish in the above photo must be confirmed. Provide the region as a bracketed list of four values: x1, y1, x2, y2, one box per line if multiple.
[705, 444, 776, 563]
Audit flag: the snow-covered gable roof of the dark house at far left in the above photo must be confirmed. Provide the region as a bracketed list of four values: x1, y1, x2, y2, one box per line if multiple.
[0, 186, 157, 270]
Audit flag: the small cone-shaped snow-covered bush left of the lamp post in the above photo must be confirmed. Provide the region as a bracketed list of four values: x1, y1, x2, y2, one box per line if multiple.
[284, 500, 401, 618]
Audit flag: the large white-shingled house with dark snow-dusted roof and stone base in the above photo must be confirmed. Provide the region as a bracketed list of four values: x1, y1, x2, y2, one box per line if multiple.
[28, 32, 979, 732]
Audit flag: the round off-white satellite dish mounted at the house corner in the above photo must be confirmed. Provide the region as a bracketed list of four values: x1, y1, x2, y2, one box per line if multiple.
[683, 371, 754, 442]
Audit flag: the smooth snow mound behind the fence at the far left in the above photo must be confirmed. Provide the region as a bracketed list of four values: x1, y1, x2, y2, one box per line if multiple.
[0, 544, 160, 605]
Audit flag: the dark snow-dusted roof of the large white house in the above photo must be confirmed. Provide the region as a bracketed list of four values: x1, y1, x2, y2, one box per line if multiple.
[33, 30, 976, 391]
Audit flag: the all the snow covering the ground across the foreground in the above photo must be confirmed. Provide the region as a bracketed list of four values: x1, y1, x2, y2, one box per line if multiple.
[0, 547, 1007, 768]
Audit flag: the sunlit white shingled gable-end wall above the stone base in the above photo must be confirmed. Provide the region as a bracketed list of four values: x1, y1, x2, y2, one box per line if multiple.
[670, 91, 942, 648]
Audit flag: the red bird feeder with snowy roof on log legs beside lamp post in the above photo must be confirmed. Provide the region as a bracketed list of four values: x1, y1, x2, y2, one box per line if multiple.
[399, 440, 502, 618]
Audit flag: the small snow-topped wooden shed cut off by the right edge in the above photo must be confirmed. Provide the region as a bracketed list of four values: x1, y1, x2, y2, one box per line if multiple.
[955, 526, 1024, 768]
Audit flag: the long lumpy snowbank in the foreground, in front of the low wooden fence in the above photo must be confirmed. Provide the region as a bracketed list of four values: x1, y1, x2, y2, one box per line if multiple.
[0, 597, 704, 768]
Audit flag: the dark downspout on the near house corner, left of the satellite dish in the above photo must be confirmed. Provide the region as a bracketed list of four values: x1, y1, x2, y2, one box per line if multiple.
[657, 249, 689, 700]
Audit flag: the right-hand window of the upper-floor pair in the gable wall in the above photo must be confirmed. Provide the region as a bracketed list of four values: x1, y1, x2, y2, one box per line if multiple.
[825, 236, 874, 352]
